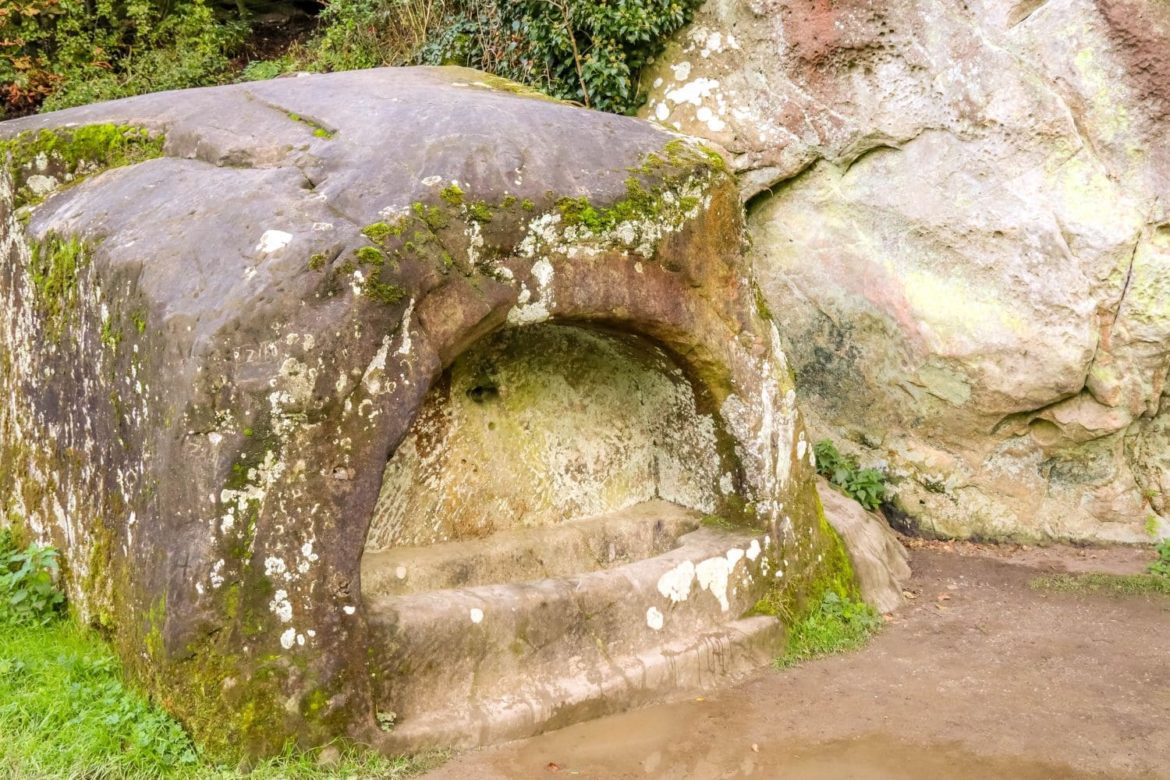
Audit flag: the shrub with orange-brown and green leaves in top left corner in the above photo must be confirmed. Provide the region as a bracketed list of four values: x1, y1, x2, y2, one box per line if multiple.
[0, 0, 245, 115]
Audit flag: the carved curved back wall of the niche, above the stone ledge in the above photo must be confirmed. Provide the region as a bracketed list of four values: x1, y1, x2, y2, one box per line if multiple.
[366, 324, 737, 568]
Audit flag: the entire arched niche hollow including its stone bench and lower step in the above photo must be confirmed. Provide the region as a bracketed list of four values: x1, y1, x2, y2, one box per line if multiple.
[362, 323, 777, 747]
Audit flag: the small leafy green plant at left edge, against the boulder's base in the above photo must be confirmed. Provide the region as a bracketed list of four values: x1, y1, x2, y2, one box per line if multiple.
[0, 530, 66, 626]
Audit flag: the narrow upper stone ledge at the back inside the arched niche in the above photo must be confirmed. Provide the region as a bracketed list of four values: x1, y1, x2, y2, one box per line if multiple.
[362, 501, 700, 599]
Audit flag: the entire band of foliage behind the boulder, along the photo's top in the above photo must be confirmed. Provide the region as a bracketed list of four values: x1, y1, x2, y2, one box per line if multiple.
[0, 0, 702, 118]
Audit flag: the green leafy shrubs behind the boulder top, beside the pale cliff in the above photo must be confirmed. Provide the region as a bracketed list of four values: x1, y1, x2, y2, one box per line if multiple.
[317, 0, 702, 113]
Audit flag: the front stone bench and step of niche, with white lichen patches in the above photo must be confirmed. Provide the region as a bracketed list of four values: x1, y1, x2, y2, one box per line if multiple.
[366, 505, 783, 747]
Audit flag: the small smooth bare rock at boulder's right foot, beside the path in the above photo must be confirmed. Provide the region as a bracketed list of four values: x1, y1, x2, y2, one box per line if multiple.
[817, 478, 910, 614]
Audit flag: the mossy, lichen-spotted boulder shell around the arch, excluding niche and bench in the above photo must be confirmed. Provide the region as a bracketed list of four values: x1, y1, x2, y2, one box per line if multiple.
[0, 69, 851, 751]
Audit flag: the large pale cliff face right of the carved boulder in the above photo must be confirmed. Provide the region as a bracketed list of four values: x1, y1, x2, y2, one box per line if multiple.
[646, 0, 1170, 541]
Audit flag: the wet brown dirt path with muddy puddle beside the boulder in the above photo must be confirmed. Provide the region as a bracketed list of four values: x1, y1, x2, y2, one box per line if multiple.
[427, 545, 1170, 780]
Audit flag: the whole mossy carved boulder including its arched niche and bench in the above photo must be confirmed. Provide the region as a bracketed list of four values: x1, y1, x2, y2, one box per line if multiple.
[0, 69, 852, 752]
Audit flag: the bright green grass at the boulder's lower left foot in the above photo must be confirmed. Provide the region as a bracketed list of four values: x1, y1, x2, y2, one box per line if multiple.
[0, 619, 445, 780]
